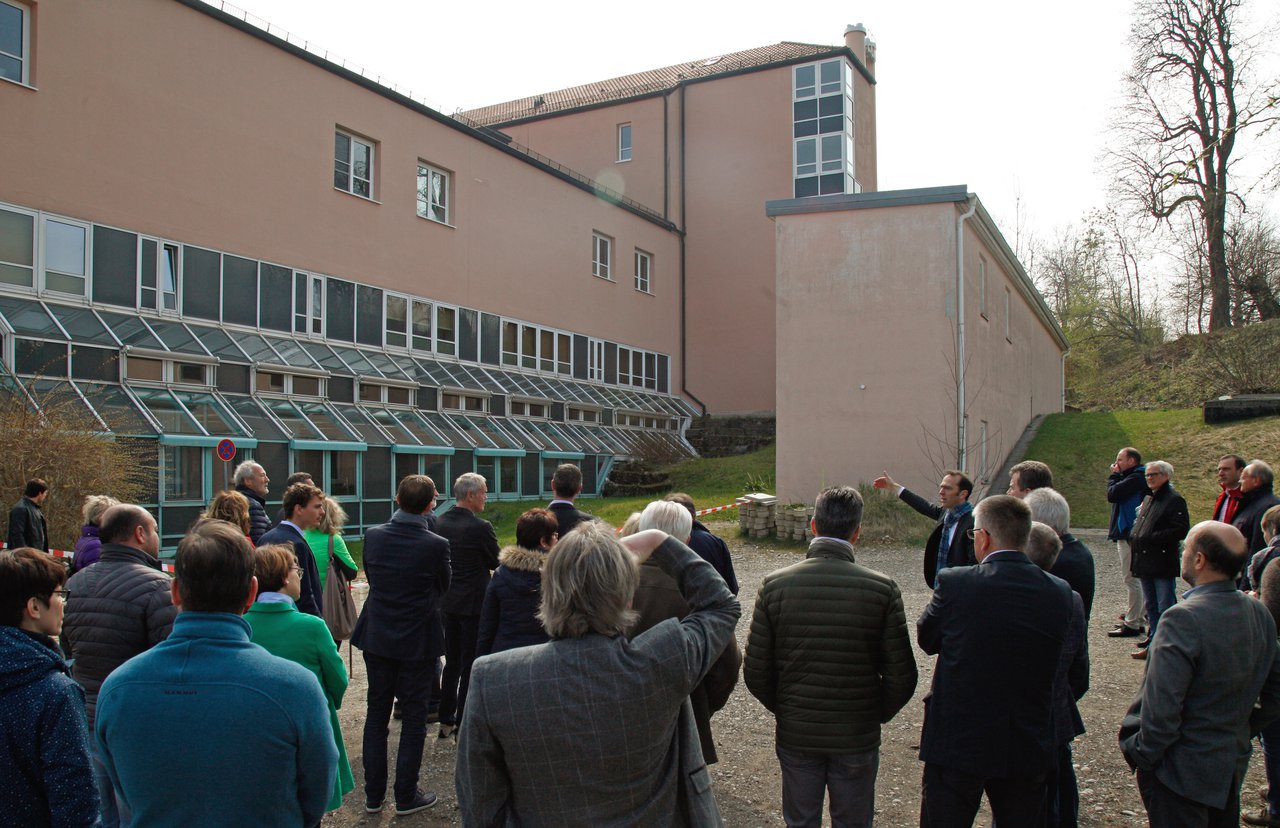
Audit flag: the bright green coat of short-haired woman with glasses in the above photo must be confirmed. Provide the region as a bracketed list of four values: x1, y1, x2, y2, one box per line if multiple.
[244, 603, 356, 810]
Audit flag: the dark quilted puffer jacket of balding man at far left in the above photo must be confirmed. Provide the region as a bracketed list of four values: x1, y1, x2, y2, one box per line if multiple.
[63, 544, 178, 732]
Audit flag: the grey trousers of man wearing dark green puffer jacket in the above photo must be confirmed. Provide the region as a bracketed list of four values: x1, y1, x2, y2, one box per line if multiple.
[776, 747, 879, 828]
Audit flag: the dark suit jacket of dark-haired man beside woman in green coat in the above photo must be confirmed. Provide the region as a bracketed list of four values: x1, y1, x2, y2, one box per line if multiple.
[351, 511, 449, 662]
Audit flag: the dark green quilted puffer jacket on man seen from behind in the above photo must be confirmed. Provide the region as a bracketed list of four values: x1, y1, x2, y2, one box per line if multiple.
[742, 537, 916, 755]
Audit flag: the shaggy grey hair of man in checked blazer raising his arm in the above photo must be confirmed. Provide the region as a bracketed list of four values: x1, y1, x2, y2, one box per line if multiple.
[538, 521, 640, 639]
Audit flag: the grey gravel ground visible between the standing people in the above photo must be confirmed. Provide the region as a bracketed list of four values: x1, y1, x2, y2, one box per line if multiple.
[324, 523, 1265, 828]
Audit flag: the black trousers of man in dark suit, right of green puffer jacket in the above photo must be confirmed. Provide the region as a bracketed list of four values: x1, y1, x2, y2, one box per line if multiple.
[920, 763, 1046, 828]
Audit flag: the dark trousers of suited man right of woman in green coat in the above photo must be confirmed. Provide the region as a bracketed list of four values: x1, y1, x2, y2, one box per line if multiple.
[364, 653, 439, 804]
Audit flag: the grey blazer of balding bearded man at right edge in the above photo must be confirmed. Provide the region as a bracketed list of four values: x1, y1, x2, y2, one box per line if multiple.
[1120, 581, 1280, 808]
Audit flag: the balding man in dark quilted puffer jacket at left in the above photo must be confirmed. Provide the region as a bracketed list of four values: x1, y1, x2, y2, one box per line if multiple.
[63, 504, 178, 828]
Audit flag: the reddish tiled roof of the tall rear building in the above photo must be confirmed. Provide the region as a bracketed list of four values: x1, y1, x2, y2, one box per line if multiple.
[461, 41, 842, 127]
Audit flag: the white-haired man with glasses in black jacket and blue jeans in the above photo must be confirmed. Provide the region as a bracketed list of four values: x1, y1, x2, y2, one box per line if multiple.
[1129, 459, 1192, 659]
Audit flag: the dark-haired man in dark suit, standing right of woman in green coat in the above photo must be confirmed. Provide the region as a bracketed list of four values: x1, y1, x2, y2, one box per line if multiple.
[351, 475, 449, 814]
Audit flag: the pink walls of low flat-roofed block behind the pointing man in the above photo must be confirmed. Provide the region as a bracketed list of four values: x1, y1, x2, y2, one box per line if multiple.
[777, 202, 1061, 502]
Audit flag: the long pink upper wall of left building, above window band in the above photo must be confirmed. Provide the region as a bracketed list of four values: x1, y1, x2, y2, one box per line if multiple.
[0, 0, 681, 368]
